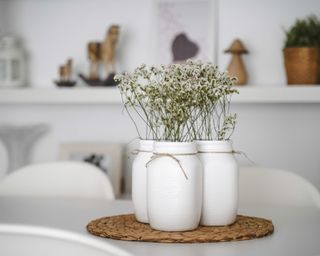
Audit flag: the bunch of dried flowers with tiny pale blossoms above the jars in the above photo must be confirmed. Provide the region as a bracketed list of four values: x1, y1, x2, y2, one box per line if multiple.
[115, 60, 238, 142]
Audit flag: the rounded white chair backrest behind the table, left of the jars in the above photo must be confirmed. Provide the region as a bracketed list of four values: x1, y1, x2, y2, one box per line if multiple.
[0, 161, 114, 199]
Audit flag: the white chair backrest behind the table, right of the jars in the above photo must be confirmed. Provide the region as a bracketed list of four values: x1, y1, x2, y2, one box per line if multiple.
[239, 167, 320, 208]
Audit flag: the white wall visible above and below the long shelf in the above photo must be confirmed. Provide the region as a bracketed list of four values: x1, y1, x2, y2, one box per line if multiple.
[0, 0, 320, 192]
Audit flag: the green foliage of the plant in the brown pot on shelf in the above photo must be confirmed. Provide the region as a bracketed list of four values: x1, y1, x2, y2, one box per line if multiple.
[284, 15, 320, 47]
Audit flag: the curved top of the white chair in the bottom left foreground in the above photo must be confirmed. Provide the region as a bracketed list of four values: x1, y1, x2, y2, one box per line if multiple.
[0, 223, 132, 256]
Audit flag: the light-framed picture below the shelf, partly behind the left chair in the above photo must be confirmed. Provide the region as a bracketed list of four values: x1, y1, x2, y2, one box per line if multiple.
[60, 143, 123, 196]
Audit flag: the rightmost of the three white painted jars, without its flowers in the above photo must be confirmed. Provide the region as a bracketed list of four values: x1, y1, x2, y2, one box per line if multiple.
[196, 141, 238, 226]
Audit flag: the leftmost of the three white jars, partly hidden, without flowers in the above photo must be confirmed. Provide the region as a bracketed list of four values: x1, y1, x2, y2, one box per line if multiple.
[132, 140, 154, 223]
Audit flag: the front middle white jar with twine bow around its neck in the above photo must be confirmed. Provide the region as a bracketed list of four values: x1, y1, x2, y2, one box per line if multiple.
[147, 142, 202, 231]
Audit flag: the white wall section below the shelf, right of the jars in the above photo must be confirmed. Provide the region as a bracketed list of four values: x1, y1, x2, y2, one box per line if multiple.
[233, 104, 320, 189]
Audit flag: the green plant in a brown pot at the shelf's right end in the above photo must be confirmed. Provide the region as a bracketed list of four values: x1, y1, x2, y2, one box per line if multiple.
[283, 16, 320, 85]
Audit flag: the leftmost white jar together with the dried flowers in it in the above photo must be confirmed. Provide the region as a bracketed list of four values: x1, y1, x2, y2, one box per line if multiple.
[114, 65, 158, 223]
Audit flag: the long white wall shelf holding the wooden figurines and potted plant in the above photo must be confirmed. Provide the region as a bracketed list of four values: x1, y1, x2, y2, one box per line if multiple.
[0, 85, 320, 105]
